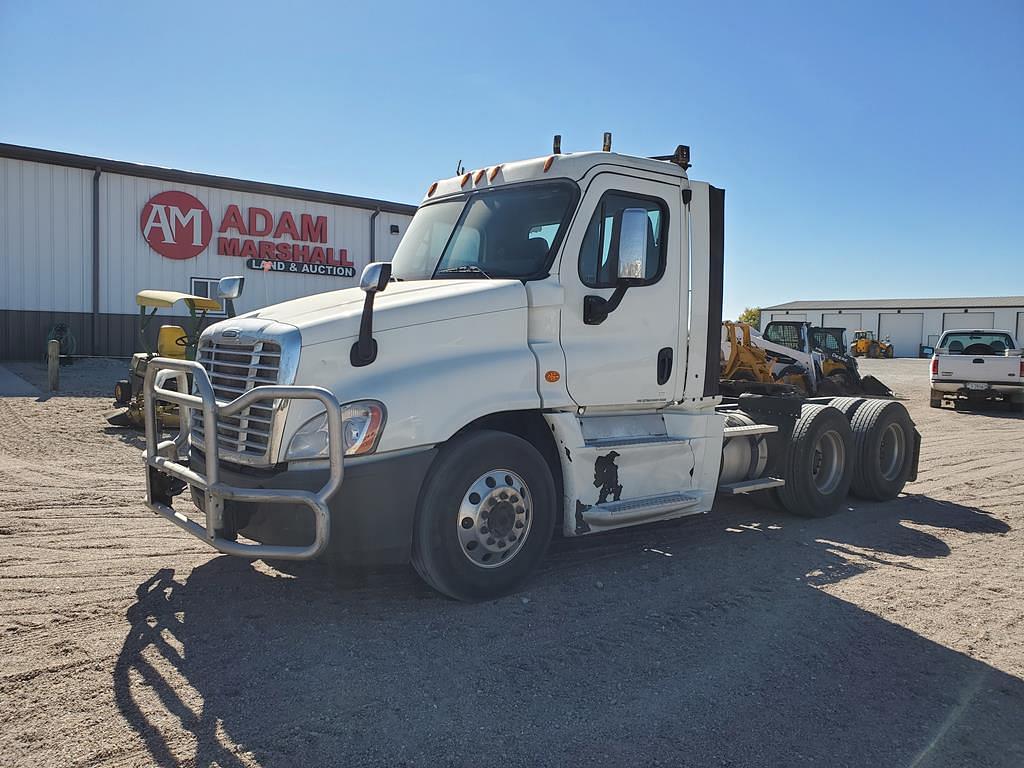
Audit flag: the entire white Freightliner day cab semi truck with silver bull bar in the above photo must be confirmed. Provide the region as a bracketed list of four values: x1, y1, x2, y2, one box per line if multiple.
[145, 139, 920, 600]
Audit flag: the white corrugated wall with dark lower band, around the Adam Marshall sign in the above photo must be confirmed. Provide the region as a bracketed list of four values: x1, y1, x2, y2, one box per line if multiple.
[0, 154, 412, 359]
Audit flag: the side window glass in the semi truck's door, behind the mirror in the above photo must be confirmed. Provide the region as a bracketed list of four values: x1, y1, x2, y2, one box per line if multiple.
[580, 191, 669, 288]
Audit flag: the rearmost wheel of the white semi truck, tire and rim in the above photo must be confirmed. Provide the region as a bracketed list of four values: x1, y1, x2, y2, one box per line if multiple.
[850, 400, 914, 502]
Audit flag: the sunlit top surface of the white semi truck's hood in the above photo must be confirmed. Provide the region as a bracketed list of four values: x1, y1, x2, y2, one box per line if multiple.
[244, 279, 526, 346]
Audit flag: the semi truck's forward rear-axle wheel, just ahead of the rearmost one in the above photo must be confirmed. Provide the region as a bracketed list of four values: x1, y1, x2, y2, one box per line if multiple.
[777, 403, 854, 517]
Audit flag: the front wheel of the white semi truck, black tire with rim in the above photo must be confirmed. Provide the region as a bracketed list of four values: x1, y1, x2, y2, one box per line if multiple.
[413, 430, 558, 601]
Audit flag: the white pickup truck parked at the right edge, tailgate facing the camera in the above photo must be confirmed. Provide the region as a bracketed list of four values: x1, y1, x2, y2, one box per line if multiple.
[930, 330, 1024, 408]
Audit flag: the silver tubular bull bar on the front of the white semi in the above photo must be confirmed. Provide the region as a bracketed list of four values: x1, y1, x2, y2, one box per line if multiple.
[144, 357, 345, 560]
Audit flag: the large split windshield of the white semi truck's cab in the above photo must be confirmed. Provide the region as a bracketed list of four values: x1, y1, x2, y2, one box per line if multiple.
[392, 182, 577, 280]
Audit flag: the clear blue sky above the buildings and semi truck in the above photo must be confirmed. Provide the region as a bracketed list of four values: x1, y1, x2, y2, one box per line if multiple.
[0, 0, 1024, 315]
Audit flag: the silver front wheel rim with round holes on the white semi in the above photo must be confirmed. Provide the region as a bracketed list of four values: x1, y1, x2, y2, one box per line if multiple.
[455, 469, 534, 568]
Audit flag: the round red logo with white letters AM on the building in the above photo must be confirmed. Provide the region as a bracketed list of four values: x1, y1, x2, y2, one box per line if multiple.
[139, 189, 213, 260]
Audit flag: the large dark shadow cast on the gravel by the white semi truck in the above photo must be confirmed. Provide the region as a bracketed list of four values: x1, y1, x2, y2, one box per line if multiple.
[114, 497, 1024, 766]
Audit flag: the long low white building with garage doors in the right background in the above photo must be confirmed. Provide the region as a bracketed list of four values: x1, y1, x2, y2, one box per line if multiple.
[761, 296, 1024, 357]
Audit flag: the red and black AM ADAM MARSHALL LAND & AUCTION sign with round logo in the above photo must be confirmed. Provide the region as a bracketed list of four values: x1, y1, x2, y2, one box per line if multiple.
[139, 190, 355, 278]
